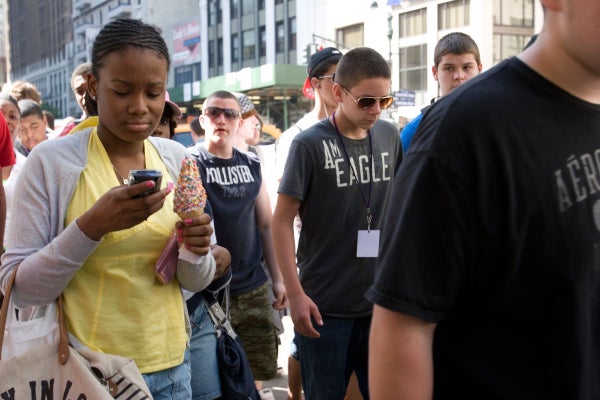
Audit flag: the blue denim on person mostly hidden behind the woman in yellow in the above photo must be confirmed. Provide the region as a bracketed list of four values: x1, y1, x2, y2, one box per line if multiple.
[190, 302, 221, 400]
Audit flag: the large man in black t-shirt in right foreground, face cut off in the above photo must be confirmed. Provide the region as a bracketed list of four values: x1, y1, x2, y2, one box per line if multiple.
[367, 0, 600, 400]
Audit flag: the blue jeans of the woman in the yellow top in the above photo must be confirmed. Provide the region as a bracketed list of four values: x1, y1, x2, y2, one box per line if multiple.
[143, 349, 192, 400]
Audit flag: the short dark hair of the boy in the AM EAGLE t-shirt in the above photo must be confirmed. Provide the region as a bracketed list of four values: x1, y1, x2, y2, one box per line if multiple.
[335, 47, 392, 90]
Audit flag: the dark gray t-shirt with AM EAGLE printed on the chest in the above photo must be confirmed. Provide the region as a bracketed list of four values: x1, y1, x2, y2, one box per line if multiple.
[279, 120, 402, 318]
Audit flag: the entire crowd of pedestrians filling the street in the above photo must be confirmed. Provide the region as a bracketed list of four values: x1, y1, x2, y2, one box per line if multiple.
[0, 0, 600, 400]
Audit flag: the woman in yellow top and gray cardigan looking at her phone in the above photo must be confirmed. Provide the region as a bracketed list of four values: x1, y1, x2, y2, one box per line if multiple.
[0, 19, 214, 399]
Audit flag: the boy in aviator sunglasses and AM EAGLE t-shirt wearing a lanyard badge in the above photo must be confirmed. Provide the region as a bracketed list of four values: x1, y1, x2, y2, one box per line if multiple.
[273, 47, 402, 400]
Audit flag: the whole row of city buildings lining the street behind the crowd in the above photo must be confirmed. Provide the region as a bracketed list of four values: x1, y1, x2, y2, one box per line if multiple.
[0, 0, 543, 129]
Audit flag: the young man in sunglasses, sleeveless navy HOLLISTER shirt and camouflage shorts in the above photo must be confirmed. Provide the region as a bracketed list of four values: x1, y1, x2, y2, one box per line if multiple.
[190, 90, 287, 389]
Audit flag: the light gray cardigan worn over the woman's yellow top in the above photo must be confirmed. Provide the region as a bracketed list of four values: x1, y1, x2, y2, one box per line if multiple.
[0, 129, 215, 307]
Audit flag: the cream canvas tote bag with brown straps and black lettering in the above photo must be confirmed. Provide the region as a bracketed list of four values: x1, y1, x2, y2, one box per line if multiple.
[0, 271, 152, 400]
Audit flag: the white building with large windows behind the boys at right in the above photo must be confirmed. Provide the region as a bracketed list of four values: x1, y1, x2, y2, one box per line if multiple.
[317, 0, 543, 121]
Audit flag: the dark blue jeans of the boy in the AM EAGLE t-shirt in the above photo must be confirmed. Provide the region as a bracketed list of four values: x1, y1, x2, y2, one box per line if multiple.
[298, 316, 371, 400]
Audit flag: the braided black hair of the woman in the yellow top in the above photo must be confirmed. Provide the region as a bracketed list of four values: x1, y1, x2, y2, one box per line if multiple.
[92, 18, 171, 77]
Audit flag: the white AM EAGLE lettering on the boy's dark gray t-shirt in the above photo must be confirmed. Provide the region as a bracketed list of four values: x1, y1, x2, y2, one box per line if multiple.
[322, 140, 392, 188]
